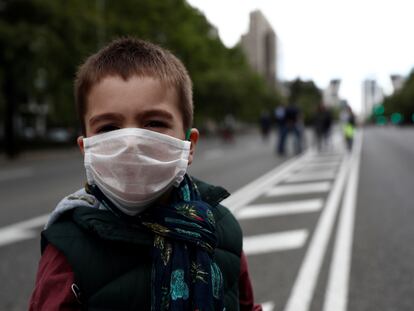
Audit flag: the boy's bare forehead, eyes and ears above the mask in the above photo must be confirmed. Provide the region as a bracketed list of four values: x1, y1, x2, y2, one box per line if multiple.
[78, 76, 199, 164]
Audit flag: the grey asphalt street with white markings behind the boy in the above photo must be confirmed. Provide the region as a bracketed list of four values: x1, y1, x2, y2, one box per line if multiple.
[0, 127, 414, 311]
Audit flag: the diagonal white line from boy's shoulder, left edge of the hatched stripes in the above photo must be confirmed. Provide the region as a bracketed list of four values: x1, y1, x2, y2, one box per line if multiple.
[221, 151, 310, 213]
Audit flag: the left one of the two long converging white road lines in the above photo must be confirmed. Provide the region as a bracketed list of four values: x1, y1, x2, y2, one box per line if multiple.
[284, 156, 349, 311]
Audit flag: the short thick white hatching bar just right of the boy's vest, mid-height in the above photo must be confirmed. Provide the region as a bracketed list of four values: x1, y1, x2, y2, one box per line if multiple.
[243, 230, 308, 255]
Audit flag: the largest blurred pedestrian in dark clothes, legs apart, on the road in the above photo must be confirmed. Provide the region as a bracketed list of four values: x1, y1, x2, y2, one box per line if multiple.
[277, 102, 303, 156]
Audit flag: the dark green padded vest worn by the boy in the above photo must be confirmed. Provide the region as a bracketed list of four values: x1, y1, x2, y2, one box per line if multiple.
[42, 178, 242, 311]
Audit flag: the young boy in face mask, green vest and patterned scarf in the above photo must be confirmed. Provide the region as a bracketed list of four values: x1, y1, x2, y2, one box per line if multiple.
[30, 38, 260, 311]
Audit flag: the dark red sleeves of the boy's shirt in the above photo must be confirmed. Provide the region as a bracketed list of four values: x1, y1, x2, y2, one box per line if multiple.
[29, 244, 262, 311]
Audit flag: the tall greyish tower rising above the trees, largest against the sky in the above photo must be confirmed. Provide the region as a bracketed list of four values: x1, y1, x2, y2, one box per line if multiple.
[241, 10, 277, 87]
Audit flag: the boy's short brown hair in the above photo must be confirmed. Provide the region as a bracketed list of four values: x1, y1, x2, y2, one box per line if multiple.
[74, 37, 193, 135]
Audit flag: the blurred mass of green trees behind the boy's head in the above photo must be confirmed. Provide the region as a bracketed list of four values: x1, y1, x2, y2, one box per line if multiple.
[0, 0, 280, 133]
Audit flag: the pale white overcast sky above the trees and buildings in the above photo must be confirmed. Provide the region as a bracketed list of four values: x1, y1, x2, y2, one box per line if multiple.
[188, 0, 414, 111]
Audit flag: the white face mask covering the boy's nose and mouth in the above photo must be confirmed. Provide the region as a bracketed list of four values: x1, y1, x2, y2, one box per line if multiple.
[83, 128, 191, 215]
